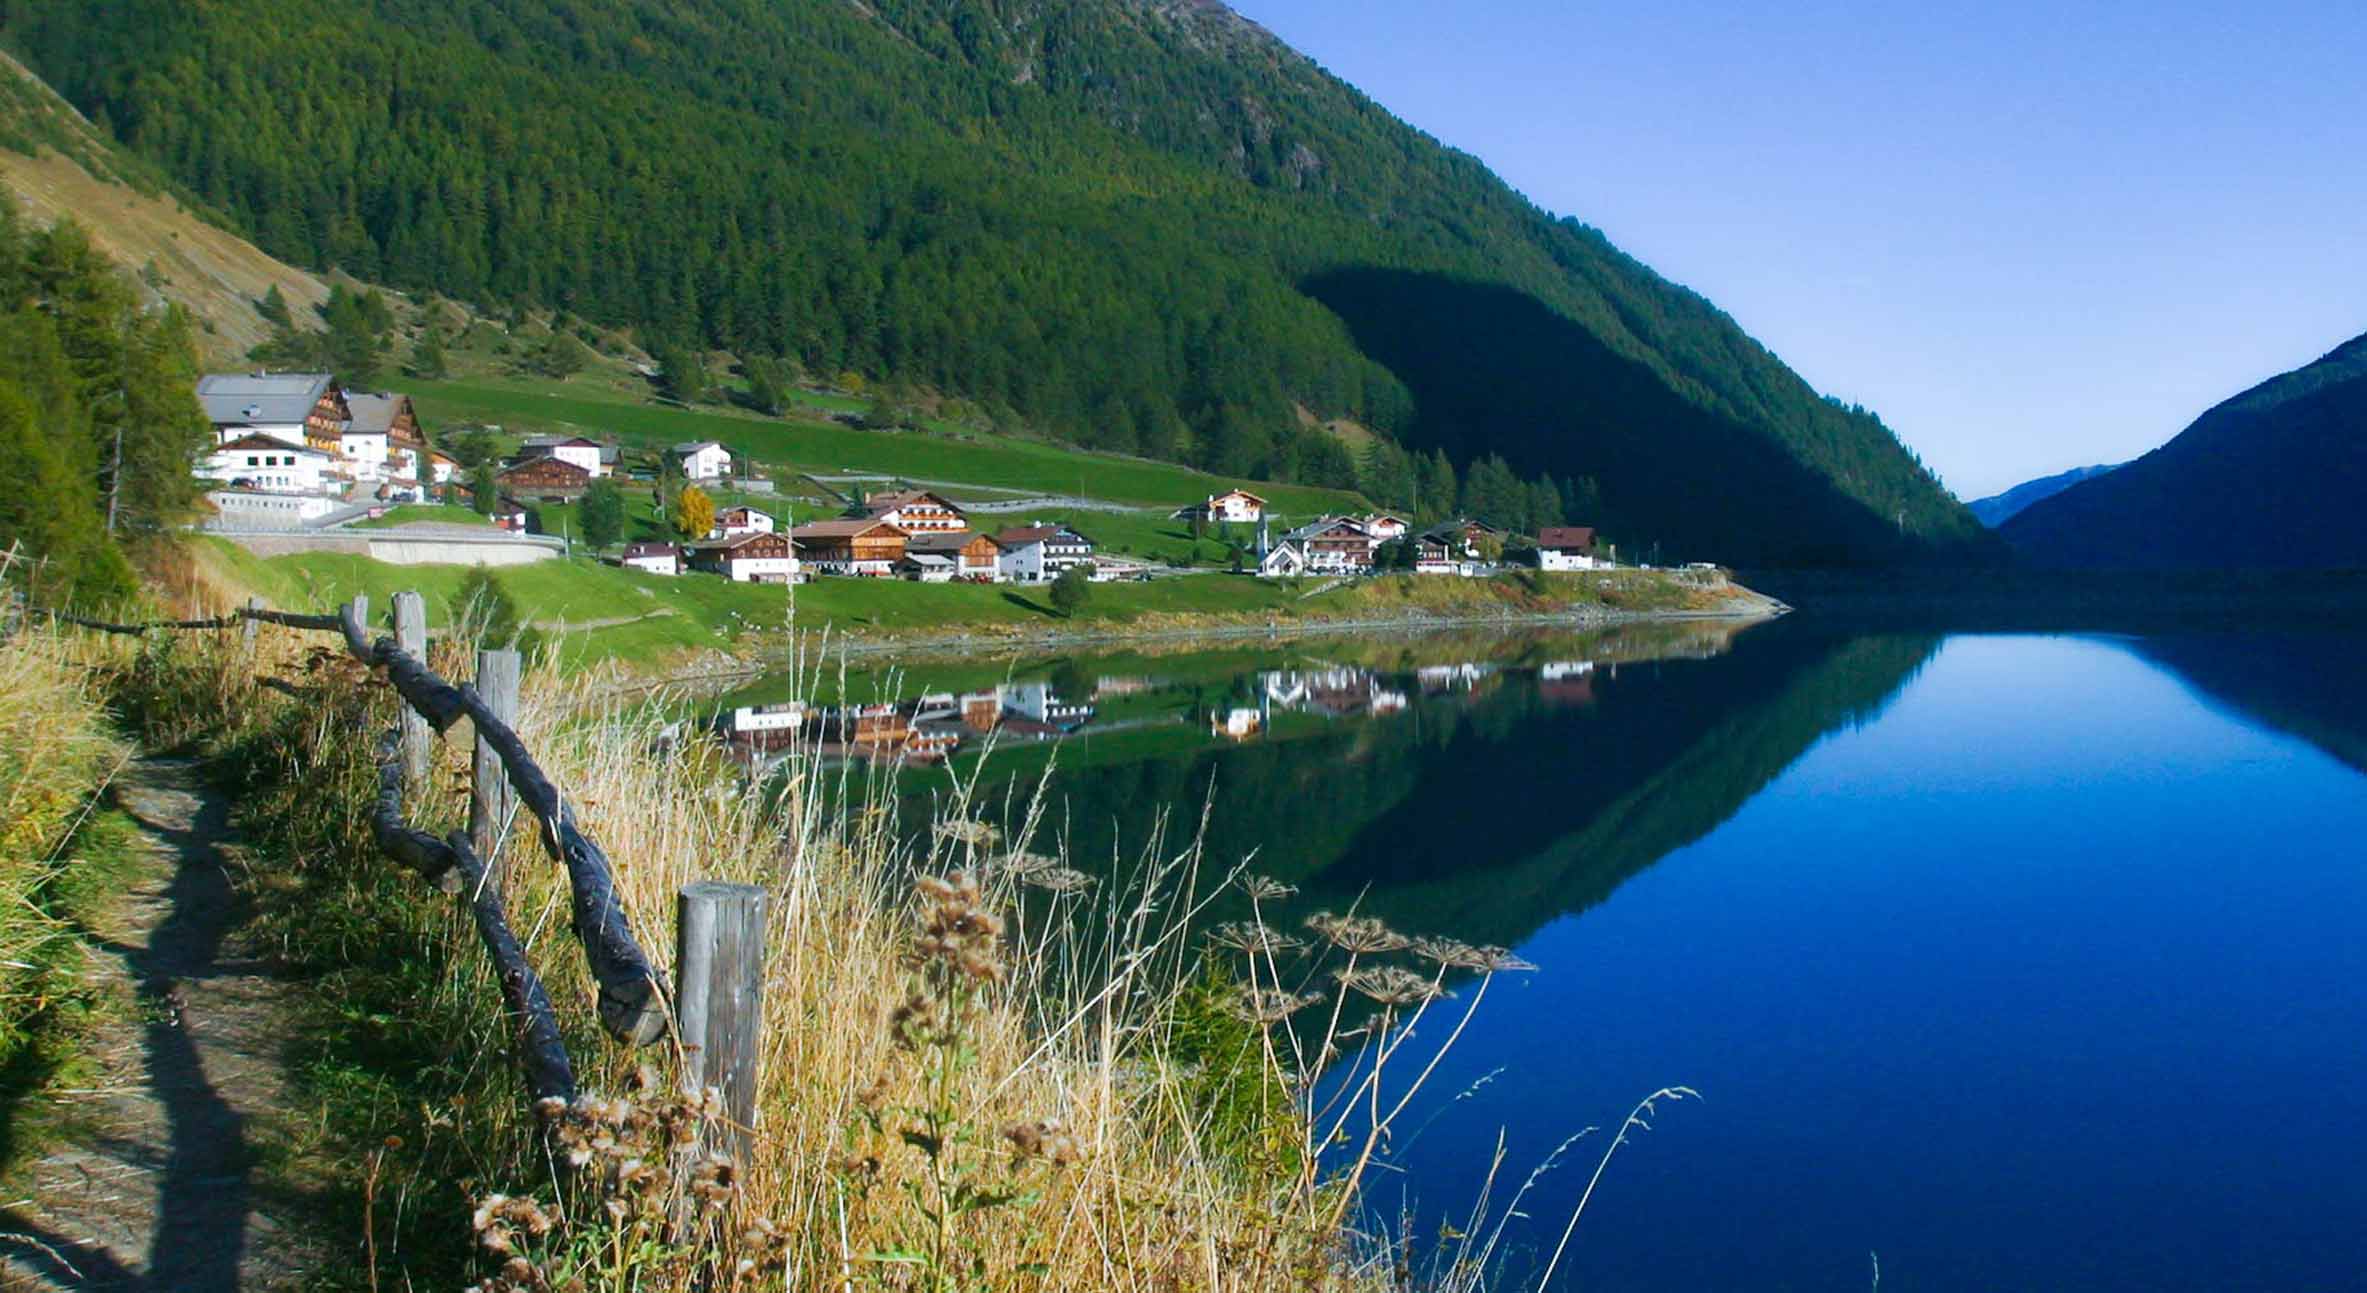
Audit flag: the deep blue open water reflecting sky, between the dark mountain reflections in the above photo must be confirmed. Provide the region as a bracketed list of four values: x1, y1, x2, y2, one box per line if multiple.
[1378, 637, 2367, 1291]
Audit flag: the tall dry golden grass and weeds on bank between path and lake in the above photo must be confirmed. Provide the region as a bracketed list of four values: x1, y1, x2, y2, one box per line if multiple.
[23, 575, 1666, 1293]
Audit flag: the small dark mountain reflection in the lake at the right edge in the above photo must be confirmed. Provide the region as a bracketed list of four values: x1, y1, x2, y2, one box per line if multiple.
[2130, 632, 2367, 772]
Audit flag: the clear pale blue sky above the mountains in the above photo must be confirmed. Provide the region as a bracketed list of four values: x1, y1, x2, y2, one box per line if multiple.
[1233, 0, 2367, 497]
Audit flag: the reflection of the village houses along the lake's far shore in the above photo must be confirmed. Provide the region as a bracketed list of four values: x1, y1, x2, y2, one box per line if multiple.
[717, 620, 1728, 765]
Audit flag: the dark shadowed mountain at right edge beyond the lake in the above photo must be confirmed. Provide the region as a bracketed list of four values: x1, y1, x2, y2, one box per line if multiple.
[1998, 336, 2367, 568]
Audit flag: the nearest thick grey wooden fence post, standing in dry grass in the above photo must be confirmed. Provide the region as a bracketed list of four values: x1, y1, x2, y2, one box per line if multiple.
[675, 881, 769, 1163]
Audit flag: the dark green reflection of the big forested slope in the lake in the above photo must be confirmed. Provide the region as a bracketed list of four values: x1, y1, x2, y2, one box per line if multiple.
[961, 625, 1936, 945]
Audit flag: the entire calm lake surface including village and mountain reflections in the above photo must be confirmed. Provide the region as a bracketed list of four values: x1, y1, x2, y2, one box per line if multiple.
[714, 616, 2367, 1291]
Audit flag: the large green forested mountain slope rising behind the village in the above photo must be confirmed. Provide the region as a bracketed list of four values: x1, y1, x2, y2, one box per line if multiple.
[0, 0, 1981, 561]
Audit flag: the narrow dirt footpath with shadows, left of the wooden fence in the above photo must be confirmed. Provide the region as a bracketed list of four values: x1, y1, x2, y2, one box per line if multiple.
[0, 758, 322, 1293]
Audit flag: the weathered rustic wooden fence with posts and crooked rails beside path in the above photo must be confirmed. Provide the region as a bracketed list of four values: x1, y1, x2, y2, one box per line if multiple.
[36, 592, 767, 1122]
